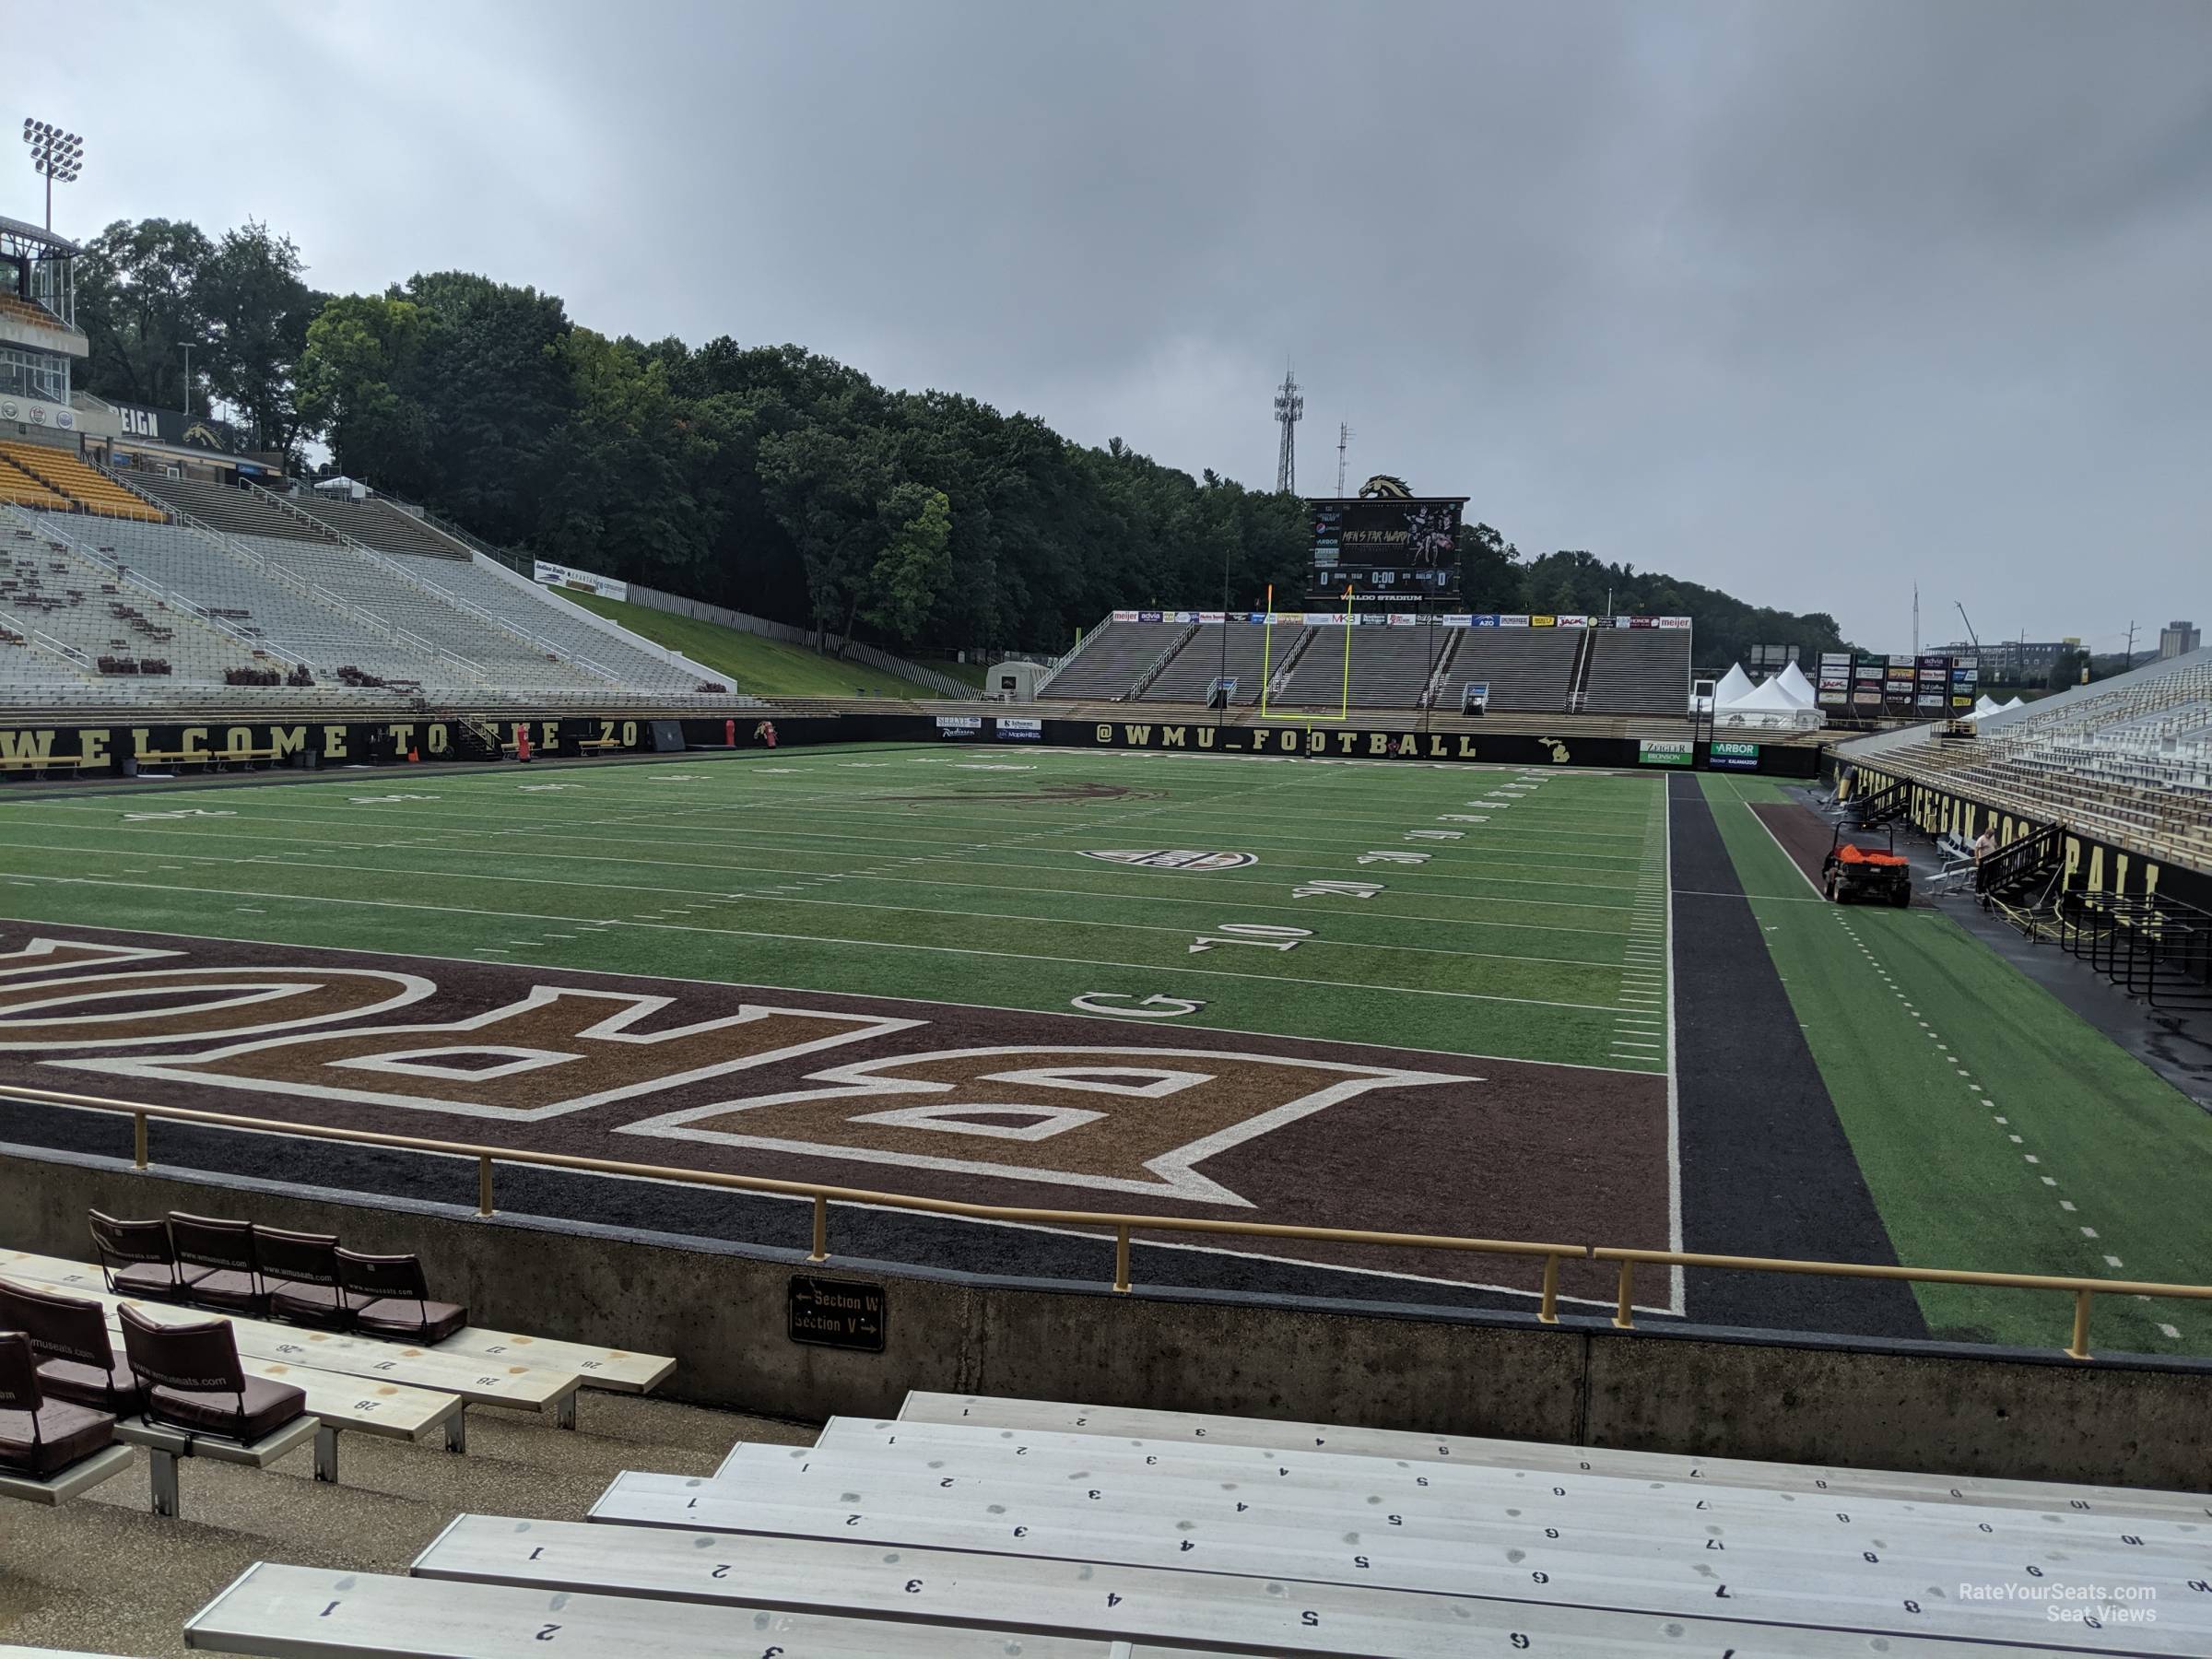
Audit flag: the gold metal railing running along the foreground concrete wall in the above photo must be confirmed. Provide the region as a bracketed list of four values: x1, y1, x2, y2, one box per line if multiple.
[0, 1084, 2212, 1360]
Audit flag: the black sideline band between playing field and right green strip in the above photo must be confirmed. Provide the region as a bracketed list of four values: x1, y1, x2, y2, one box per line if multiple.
[1668, 776, 1926, 1336]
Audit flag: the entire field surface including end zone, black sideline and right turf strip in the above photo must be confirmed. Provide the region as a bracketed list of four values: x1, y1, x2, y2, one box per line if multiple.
[0, 741, 2212, 1354]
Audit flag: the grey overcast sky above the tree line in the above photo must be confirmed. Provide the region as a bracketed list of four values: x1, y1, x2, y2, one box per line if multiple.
[29, 0, 2212, 651]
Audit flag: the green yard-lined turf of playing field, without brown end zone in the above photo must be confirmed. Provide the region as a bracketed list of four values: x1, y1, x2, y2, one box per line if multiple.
[0, 746, 1665, 1071]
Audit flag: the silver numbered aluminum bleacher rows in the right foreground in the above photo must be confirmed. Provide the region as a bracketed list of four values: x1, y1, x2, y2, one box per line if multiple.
[316, 1394, 2212, 1659]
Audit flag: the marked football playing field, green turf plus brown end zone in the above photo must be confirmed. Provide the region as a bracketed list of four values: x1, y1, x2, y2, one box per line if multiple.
[0, 743, 1681, 1312]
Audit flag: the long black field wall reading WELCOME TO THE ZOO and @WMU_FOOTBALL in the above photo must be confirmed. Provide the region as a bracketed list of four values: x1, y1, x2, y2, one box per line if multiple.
[0, 710, 1823, 779]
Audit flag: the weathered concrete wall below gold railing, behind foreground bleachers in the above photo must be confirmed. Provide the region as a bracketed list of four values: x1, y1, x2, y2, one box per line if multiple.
[17, 1148, 2212, 1491]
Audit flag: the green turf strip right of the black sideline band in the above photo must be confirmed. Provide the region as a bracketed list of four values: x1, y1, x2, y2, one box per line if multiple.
[1703, 774, 2212, 1354]
